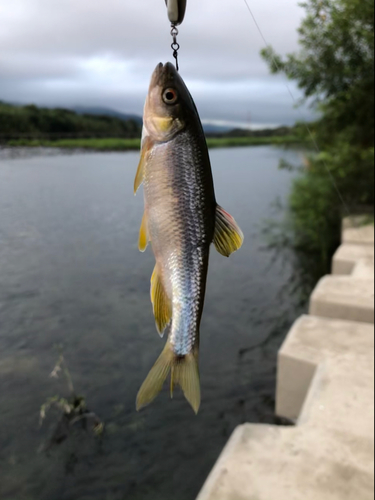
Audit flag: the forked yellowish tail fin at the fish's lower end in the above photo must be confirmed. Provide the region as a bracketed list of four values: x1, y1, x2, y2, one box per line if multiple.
[137, 342, 201, 414]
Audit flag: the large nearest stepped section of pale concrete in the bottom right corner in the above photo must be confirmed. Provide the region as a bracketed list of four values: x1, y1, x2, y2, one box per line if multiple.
[198, 316, 374, 500]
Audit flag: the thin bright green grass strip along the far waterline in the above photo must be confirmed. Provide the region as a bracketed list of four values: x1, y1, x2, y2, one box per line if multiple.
[7, 136, 301, 151]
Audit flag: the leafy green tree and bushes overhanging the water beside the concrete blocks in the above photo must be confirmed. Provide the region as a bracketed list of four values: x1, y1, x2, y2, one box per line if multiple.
[262, 0, 374, 286]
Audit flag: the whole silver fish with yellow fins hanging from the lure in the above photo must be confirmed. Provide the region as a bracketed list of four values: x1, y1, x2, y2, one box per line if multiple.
[134, 63, 244, 414]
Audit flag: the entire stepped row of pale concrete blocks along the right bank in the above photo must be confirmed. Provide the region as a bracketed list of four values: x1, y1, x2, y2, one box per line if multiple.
[198, 219, 374, 500]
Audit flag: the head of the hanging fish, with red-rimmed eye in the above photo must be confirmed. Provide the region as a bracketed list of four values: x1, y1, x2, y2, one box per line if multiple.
[144, 63, 195, 142]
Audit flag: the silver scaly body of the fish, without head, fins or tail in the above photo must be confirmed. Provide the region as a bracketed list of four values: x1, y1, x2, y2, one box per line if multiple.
[144, 127, 216, 356]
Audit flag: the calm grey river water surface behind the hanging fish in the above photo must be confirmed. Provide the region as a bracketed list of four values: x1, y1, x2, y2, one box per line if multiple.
[0, 147, 306, 500]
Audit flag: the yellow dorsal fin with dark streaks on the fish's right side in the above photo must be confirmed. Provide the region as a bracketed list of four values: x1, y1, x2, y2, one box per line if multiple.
[214, 205, 244, 257]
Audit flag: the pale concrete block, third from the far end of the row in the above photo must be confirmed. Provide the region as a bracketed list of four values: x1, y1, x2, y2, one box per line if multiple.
[310, 276, 374, 324]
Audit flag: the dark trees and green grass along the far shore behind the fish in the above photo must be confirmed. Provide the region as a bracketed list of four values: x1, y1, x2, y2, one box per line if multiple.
[0, 102, 304, 151]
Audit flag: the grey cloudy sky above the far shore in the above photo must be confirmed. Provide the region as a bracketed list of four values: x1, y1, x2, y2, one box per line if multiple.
[0, 0, 316, 126]
